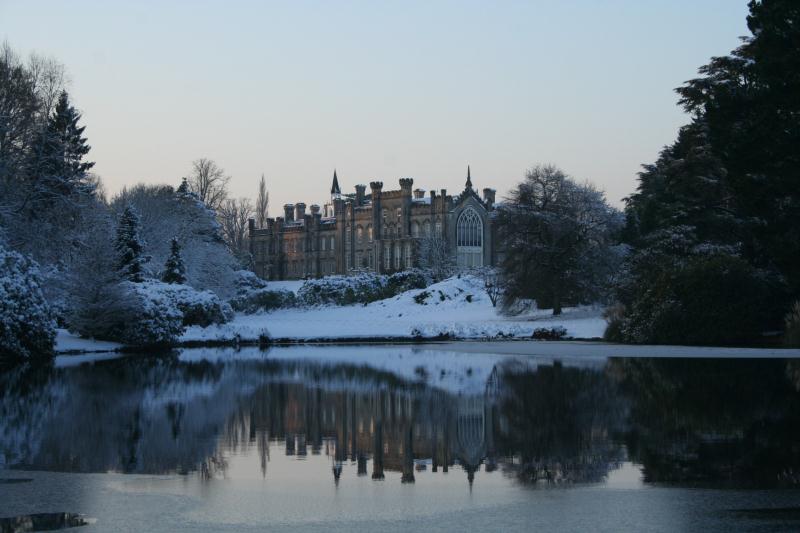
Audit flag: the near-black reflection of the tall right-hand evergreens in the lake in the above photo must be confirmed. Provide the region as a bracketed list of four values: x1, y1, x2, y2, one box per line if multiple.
[609, 359, 800, 486]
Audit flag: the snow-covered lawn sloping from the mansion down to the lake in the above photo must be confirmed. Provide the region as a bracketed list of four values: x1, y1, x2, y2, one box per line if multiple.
[181, 277, 606, 342]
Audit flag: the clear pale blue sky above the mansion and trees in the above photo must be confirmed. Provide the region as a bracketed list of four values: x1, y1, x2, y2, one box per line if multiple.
[0, 0, 747, 210]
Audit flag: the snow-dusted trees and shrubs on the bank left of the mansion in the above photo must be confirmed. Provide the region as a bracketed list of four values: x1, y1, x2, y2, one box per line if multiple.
[0, 44, 268, 358]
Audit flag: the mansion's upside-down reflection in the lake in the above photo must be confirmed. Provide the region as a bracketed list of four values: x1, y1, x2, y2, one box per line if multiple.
[219, 371, 499, 484]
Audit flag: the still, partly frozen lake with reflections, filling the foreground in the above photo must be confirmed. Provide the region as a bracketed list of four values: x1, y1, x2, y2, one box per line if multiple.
[0, 345, 800, 532]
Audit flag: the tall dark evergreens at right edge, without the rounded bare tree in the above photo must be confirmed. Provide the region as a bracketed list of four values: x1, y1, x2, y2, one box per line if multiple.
[609, 0, 800, 344]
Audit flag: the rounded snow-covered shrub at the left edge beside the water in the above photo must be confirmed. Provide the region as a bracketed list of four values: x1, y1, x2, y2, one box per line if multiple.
[0, 245, 56, 359]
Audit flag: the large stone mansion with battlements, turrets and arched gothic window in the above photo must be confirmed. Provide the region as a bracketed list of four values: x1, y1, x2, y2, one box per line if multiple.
[249, 167, 498, 280]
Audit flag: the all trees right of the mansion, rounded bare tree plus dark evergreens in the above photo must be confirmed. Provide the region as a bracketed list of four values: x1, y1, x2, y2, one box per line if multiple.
[499, 0, 800, 345]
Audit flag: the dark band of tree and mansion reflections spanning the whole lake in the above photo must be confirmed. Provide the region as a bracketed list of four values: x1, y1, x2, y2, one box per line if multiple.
[0, 352, 800, 485]
